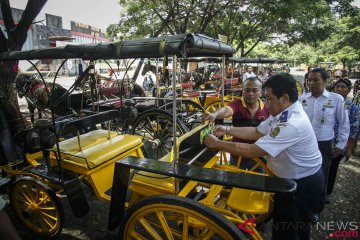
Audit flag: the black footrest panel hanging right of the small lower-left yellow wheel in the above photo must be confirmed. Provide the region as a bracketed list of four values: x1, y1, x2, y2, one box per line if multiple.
[64, 178, 89, 217]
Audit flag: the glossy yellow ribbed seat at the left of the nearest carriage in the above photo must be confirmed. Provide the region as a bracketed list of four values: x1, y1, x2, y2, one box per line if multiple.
[52, 129, 142, 169]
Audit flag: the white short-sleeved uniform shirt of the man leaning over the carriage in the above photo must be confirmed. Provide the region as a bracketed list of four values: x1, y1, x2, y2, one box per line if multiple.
[255, 102, 322, 179]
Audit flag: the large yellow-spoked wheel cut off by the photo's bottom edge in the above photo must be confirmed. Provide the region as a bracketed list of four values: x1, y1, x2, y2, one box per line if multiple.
[119, 195, 245, 239]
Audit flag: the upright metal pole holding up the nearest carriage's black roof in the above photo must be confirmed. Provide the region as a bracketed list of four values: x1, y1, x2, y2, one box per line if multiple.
[172, 55, 179, 195]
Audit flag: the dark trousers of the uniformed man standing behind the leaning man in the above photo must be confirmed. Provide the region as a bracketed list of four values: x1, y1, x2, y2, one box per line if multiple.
[314, 141, 332, 213]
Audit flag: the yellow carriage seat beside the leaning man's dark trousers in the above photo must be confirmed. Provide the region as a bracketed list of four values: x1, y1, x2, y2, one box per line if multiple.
[226, 188, 271, 214]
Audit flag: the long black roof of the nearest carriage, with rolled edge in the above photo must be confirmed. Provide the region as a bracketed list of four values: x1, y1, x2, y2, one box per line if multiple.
[0, 34, 234, 61]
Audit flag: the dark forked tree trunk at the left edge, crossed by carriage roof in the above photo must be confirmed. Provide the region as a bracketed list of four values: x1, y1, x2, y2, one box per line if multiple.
[0, 0, 47, 131]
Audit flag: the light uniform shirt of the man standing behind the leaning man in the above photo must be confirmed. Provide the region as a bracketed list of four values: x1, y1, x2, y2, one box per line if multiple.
[299, 90, 350, 149]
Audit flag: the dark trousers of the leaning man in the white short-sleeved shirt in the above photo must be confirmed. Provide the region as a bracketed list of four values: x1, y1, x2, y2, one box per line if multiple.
[272, 169, 324, 240]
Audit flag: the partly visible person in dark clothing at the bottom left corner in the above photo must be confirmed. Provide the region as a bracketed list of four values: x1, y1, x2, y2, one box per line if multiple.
[0, 196, 21, 240]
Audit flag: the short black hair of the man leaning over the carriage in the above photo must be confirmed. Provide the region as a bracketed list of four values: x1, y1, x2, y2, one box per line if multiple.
[264, 73, 298, 103]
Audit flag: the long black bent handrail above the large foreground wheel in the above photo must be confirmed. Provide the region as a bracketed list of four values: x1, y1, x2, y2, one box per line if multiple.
[108, 156, 297, 230]
